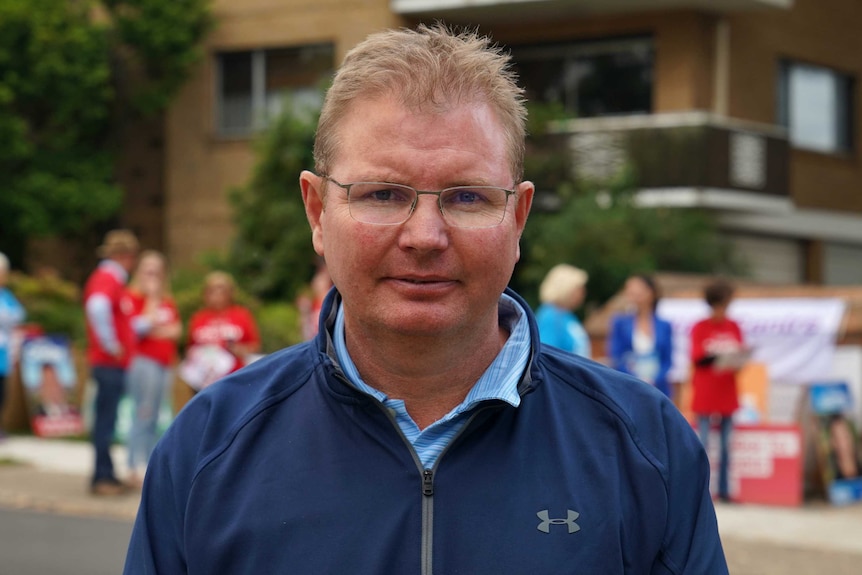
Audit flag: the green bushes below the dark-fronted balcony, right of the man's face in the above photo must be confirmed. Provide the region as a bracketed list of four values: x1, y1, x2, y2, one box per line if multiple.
[513, 169, 739, 310]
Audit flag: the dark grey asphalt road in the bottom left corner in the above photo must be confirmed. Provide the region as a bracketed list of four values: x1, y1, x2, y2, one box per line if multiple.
[0, 507, 132, 575]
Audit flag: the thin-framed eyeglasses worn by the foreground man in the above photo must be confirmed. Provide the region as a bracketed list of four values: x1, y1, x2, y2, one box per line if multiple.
[322, 176, 515, 228]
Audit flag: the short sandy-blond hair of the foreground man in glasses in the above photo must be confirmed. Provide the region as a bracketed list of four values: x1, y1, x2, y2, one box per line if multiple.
[314, 24, 527, 181]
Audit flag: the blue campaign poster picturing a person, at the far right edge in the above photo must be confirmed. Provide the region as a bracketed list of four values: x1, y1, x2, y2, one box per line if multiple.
[808, 381, 862, 505]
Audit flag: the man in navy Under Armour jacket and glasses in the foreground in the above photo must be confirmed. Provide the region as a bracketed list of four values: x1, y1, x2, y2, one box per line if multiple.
[125, 27, 727, 574]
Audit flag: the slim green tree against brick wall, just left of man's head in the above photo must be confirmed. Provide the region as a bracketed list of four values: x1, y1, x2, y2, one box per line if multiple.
[229, 104, 317, 301]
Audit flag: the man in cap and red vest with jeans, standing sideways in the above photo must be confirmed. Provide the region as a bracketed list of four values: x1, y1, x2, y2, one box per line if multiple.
[84, 230, 138, 496]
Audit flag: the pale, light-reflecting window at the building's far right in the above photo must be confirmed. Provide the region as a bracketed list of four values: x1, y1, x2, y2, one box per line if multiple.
[778, 60, 853, 153]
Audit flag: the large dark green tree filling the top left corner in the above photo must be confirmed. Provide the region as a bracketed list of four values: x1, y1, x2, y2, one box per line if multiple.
[0, 0, 210, 262]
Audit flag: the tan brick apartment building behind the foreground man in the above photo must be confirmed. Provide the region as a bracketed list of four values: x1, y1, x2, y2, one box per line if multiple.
[115, 0, 862, 285]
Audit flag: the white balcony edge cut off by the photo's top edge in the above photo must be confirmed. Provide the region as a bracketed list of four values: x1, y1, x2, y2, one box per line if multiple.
[389, 0, 794, 24]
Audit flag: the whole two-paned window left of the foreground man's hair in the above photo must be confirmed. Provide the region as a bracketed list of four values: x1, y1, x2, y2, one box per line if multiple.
[216, 44, 334, 136]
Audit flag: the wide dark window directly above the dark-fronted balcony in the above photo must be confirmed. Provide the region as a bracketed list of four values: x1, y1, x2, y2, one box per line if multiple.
[512, 37, 654, 118]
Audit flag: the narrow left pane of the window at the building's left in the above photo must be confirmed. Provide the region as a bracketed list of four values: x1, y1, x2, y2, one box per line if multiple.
[218, 52, 253, 134]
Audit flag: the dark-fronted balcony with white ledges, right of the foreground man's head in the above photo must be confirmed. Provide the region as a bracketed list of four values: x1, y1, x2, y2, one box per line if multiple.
[543, 112, 793, 213]
